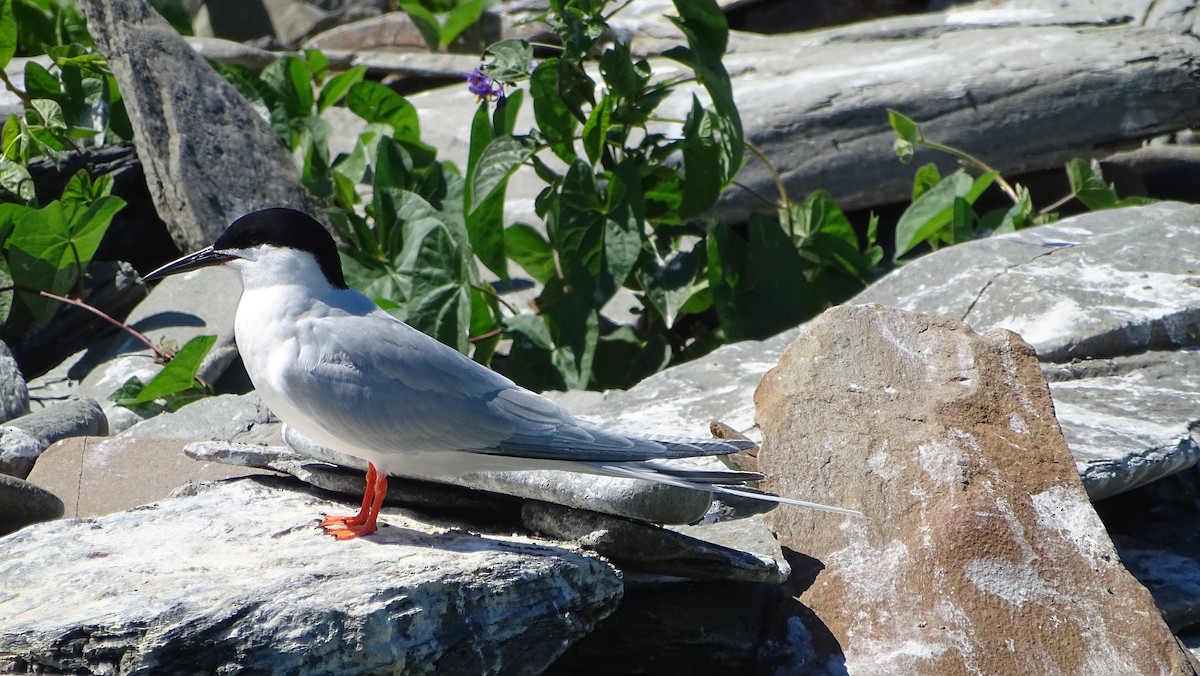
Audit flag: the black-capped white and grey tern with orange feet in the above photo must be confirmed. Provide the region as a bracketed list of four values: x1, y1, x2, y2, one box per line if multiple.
[144, 207, 860, 539]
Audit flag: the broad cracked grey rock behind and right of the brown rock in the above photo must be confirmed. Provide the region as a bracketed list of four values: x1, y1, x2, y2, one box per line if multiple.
[853, 203, 1200, 499]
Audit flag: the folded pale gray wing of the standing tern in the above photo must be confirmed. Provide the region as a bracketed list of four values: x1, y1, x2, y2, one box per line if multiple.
[288, 312, 744, 462]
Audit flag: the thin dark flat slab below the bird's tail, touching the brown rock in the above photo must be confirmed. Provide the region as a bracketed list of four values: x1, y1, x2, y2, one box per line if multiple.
[521, 502, 791, 585]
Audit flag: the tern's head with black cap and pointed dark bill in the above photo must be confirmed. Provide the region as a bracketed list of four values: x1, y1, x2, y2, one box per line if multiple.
[144, 207, 348, 289]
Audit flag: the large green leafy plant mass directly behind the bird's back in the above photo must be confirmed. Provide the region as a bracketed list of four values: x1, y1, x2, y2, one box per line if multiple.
[224, 0, 880, 389]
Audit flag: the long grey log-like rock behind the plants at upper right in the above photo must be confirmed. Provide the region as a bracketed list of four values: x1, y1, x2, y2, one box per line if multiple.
[705, 11, 1200, 220]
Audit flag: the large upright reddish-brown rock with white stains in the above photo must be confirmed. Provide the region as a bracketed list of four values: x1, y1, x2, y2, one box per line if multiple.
[755, 305, 1196, 674]
